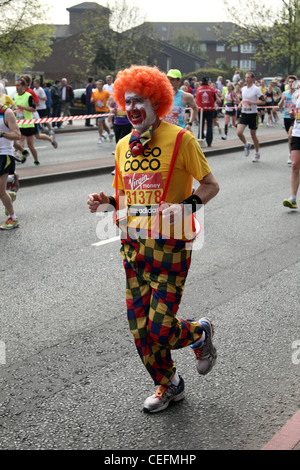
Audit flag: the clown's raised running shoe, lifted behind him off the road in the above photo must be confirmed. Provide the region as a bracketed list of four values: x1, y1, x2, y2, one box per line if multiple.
[191, 318, 217, 375]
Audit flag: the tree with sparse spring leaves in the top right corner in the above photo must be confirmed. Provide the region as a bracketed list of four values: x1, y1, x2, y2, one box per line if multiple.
[220, 0, 300, 74]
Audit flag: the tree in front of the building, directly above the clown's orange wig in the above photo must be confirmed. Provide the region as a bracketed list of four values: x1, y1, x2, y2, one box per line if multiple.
[72, 0, 152, 77]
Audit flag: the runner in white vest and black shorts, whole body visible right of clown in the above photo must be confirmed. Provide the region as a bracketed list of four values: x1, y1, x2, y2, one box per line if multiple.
[237, 72, 265, 162]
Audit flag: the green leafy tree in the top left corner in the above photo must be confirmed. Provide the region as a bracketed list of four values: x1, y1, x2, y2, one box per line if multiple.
[0, 0, 54, 73]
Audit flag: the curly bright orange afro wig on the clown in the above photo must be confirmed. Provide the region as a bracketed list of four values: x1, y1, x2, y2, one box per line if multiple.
[114, 65, 174, 119]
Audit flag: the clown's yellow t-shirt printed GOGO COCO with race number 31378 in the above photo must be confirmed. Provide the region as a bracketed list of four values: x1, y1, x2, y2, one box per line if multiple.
[113, 121, 211, 239]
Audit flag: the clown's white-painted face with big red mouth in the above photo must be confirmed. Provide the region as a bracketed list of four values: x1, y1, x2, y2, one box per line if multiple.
[125, 92, 157, 133]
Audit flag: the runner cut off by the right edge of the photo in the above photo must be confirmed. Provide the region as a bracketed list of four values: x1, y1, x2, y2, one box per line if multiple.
[283, 86, 300, 209]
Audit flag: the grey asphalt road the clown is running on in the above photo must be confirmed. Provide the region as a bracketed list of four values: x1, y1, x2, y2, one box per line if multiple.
[0, 140, 300, 451]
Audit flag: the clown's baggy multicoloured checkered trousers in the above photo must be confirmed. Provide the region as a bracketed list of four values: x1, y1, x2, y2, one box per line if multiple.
[121, 238, 203, 385]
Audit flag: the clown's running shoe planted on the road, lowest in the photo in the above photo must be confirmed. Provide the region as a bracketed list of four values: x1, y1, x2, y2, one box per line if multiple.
[143, 376, 185, 413]
